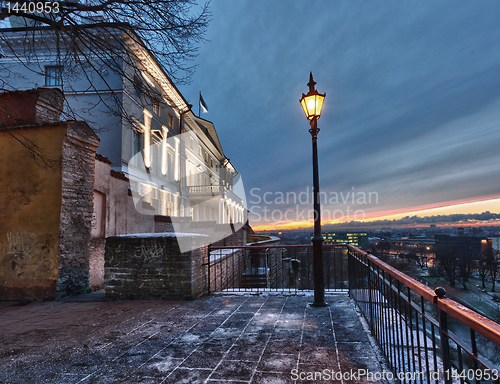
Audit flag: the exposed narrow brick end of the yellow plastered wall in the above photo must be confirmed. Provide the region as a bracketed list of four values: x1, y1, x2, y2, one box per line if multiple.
[57, 122, 99, 296]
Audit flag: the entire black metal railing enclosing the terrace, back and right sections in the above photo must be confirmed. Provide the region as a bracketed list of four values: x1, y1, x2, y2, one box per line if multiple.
[204, 245, 500, 384]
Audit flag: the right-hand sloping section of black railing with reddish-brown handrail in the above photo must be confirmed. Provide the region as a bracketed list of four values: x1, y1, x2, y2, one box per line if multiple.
[349, 246, 500, 383]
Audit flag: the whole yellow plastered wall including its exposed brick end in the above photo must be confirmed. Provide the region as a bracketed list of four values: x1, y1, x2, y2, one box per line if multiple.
[0, 122, 98, 299]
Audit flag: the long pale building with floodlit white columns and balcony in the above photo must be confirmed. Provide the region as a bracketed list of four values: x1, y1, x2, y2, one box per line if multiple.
[0, 27, 247, 231]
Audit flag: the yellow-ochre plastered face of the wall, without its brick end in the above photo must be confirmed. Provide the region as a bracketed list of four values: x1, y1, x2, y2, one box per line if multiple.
[0, 125, 66, 300]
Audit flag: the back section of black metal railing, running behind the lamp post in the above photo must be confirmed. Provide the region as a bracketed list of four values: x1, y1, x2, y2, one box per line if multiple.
[204, 245, 348, 294]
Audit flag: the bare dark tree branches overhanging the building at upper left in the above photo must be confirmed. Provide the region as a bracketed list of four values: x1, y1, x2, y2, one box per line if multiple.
[0, 0, 210, 164]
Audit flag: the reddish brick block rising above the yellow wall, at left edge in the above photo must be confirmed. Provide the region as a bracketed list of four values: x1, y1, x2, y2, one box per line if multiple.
[0, 88, 64, 127]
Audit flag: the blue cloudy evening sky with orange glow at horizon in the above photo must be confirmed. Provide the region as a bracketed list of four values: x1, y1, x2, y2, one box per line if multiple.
[179, 0, 500, 228]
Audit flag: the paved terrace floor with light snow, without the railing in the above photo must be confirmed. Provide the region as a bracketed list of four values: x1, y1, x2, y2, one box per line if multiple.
[0, 293, 387, 384]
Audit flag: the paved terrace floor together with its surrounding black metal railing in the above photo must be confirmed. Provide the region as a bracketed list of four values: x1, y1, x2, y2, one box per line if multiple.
[0, 245, 500, 383]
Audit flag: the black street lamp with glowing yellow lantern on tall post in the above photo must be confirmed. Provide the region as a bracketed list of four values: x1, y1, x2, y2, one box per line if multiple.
[300, 72, 327, 307]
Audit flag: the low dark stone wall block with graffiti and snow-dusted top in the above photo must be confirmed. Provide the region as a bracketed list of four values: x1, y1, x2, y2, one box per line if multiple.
[104, 233, 207, 300]
